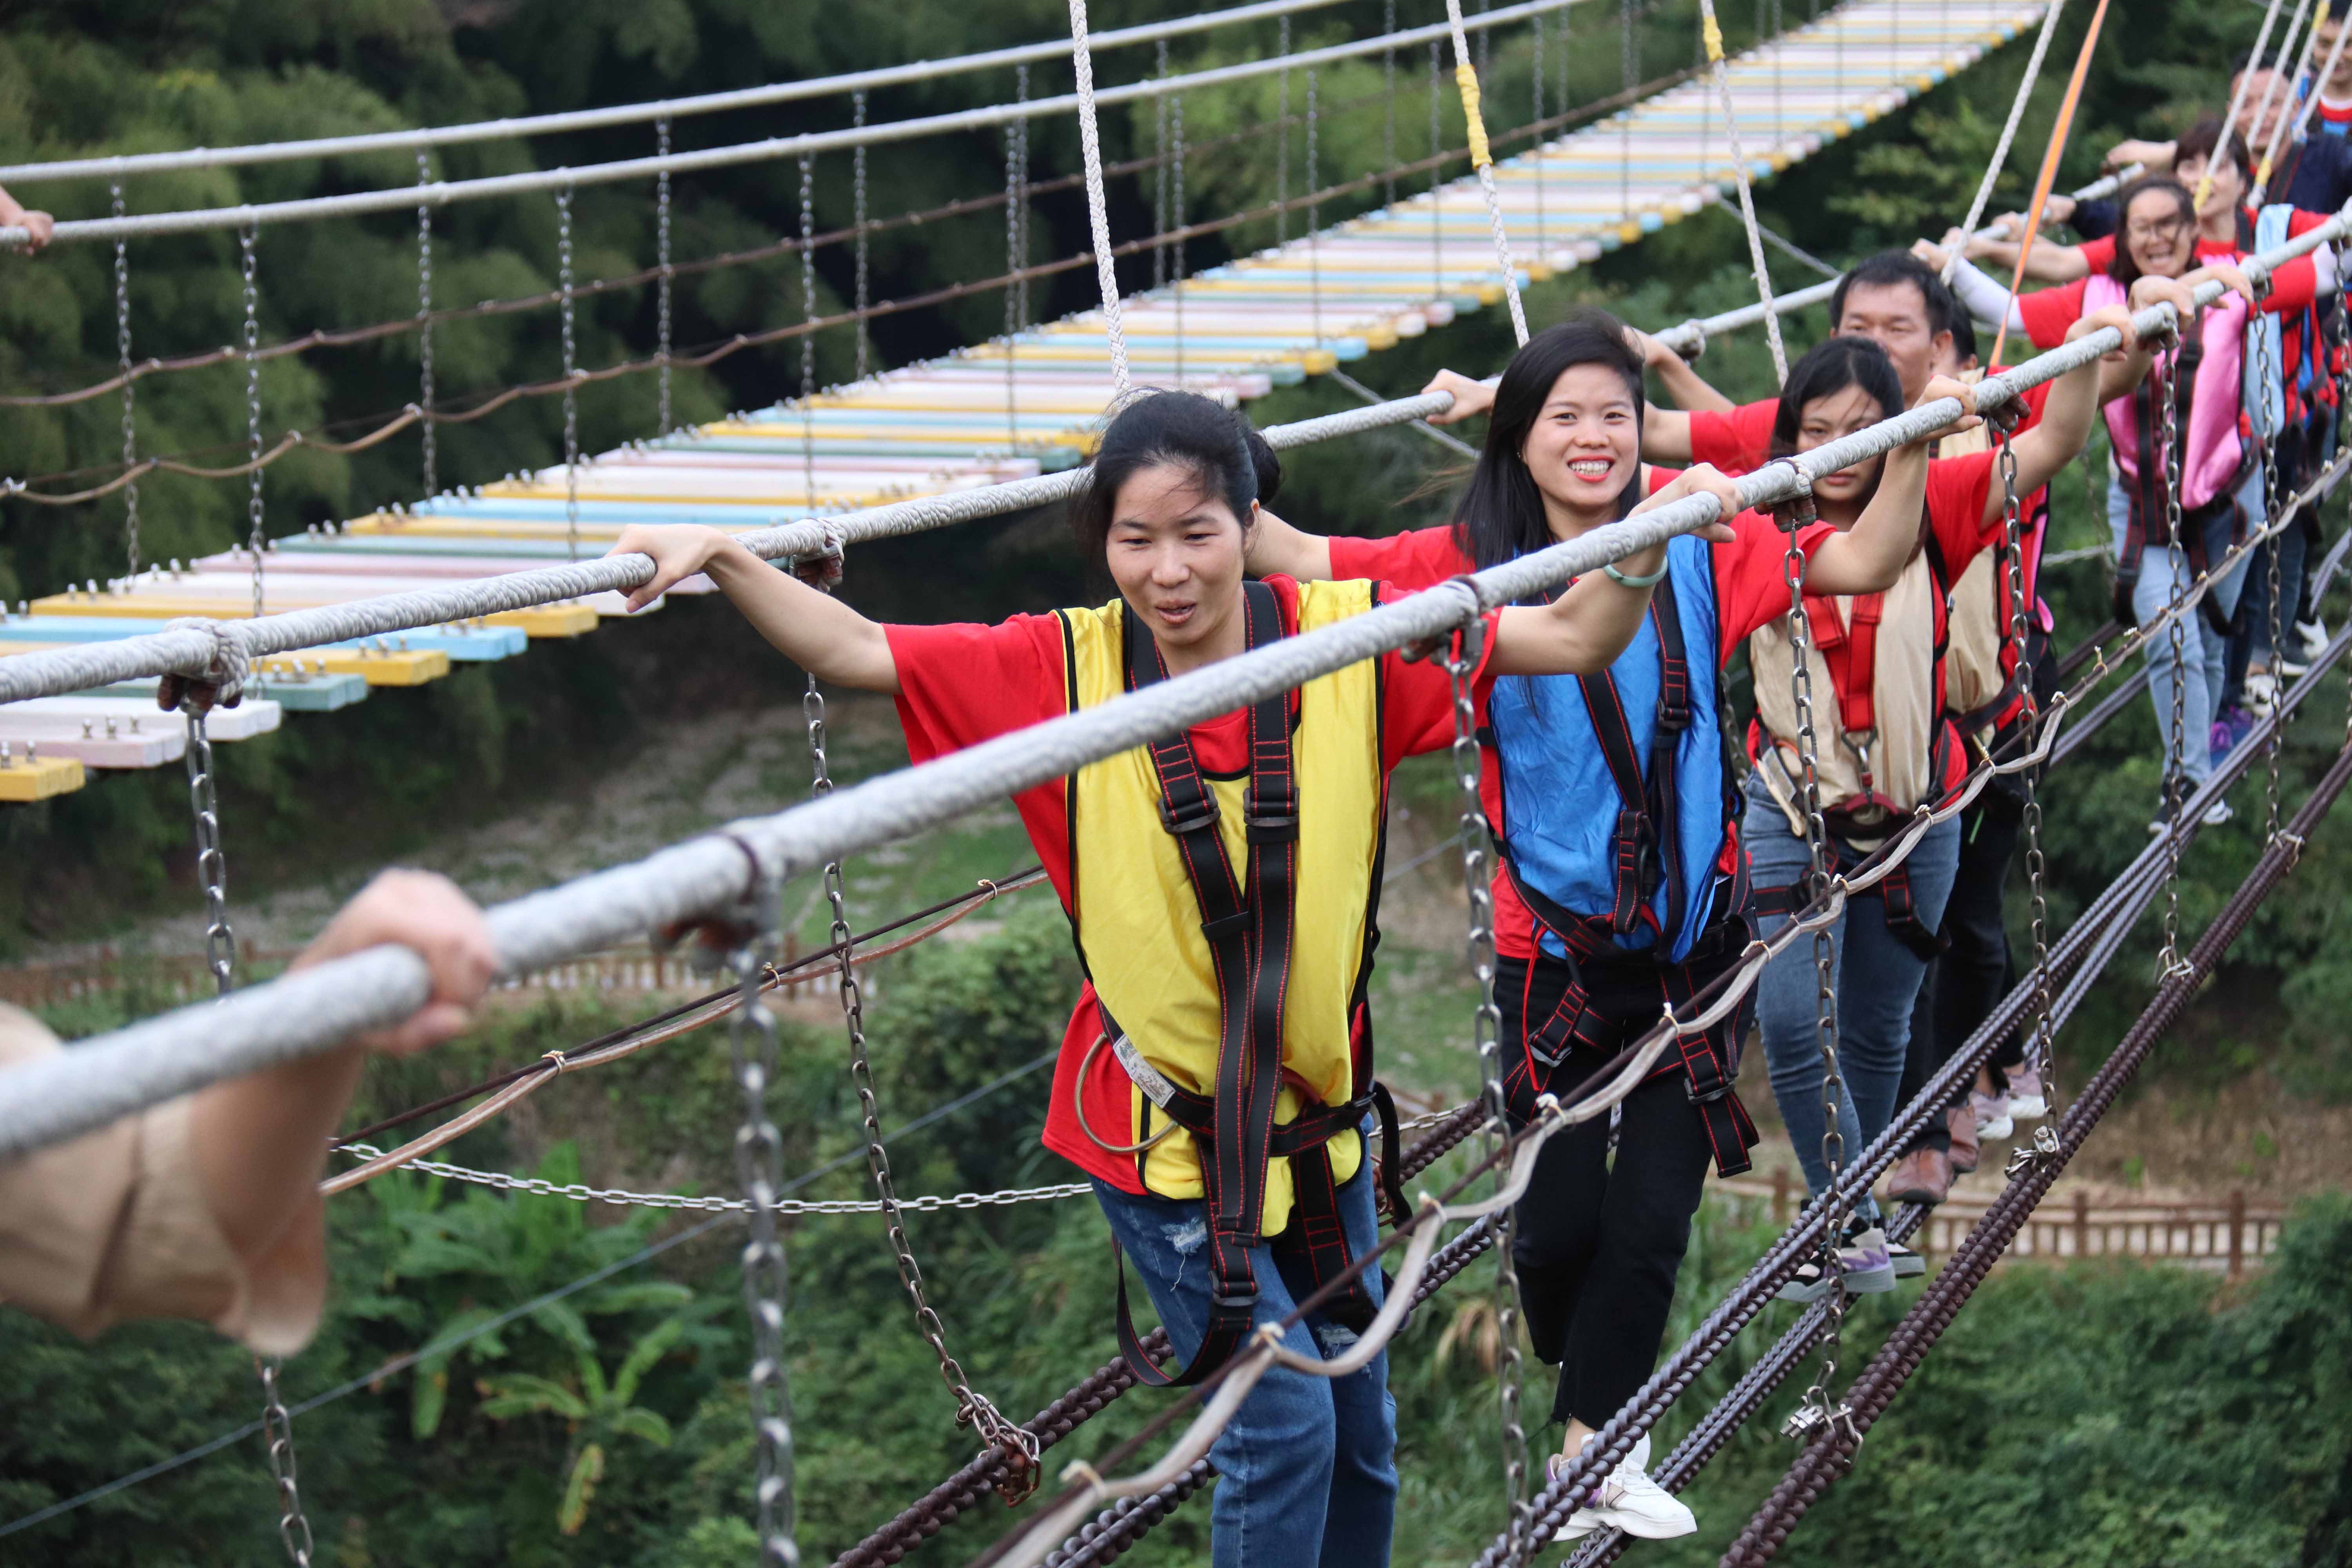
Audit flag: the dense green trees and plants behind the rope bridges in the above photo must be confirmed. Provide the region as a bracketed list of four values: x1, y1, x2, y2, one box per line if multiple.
[0, 0, 2352, 1568]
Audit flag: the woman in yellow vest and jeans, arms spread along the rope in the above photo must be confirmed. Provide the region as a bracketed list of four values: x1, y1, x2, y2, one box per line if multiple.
[614, 392, 1731, 1568]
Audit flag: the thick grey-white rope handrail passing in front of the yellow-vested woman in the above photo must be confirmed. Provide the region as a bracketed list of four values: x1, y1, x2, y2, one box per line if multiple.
[0, 214, 2347, 1157]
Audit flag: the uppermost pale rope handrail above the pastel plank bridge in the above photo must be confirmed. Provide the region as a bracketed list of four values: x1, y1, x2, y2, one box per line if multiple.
[0, 0, 1341, 186]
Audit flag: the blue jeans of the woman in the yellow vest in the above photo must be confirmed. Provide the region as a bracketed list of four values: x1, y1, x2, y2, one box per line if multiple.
[1094, 1133, 1397, 1568]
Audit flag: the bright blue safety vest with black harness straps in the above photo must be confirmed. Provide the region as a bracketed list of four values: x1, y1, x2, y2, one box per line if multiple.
[1489, 534, 1733, 964]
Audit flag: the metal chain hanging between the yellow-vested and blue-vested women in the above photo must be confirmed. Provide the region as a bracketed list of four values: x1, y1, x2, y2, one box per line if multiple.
[1437, 618, 1534, 1542]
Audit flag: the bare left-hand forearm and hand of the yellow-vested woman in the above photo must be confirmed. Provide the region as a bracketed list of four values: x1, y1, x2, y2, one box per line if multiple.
[612, 522, 898, 696]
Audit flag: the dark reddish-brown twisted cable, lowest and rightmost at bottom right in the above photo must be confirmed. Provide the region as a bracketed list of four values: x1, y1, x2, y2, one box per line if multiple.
[1722, 738, 2352, 1568]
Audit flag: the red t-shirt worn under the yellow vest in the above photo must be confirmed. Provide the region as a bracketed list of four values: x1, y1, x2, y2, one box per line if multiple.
[884, 576, 1494, 1192]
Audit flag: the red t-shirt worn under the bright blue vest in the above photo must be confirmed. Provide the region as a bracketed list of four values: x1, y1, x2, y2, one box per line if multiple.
[1331, 512, 1832, 959]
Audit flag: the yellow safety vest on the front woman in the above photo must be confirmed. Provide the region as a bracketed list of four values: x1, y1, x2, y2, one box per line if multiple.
[1056, 583, 1388, 1236]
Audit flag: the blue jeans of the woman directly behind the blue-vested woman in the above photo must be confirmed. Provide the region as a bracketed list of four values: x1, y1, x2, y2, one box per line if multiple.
[1740, 773, 1959, 1213]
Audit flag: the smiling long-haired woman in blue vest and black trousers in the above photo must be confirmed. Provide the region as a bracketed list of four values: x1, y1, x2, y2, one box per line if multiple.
[1251, 310, 1971, 1540]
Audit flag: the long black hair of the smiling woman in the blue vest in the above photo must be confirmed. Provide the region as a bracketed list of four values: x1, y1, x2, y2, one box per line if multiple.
[1454, 306, 1646, 569]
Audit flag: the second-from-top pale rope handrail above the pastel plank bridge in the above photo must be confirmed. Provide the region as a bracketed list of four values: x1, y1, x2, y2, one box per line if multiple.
[0, 0, 1588, 247]
